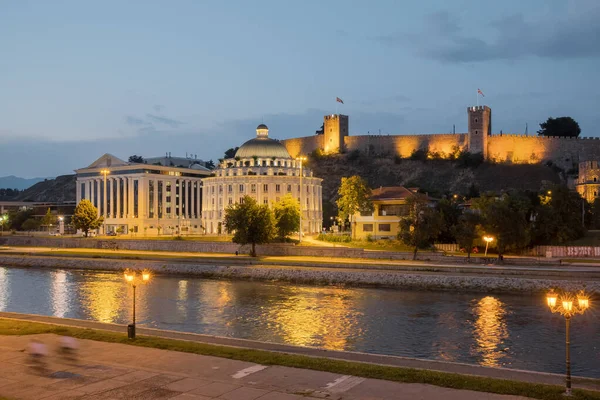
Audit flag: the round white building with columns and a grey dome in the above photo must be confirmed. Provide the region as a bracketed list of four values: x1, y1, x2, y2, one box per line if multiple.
[202, 124, 323, 234]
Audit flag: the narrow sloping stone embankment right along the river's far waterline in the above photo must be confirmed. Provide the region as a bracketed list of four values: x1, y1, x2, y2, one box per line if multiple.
[0, 255, 600, 292]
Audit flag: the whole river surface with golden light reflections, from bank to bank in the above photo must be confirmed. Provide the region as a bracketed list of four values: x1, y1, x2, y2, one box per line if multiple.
[0, 267, 600, 377]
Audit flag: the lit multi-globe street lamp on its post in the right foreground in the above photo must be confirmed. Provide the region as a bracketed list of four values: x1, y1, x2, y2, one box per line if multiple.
[546, 290, 590, 396]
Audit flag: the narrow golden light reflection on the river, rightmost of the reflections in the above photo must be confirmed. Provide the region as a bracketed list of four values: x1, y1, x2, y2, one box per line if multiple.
[473, 296, 508, 367]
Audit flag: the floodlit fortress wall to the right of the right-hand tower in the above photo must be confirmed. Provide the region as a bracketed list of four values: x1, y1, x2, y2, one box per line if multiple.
[488, 134, 600, 170]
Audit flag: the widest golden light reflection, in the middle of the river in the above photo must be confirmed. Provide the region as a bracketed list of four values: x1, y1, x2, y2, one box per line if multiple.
[266, 287, 362, 350]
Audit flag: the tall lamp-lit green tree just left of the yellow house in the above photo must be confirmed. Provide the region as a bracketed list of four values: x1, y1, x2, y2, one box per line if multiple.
[336, 175, 373, 235]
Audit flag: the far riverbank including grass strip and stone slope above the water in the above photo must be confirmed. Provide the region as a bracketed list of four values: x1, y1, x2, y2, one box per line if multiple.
[0, 252, 600, 293]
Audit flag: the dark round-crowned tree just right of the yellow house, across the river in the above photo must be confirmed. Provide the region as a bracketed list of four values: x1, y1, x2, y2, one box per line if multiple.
[398, 196, 444, 260]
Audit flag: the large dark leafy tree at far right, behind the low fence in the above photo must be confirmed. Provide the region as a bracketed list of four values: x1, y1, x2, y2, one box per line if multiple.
[532, 185, 585, 245]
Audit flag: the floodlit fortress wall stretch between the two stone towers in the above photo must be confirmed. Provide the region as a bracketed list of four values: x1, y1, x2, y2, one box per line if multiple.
[344, 133, 467, 157]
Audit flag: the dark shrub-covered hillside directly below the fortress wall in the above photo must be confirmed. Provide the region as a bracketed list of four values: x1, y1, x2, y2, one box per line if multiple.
[307, 151, 563, 219]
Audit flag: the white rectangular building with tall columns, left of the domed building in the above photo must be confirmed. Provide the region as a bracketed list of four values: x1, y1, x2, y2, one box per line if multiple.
[75, 154, 211, 235]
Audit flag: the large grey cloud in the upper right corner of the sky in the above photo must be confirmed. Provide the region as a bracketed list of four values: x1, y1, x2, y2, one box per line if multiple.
[373, 2, 600, 63]
